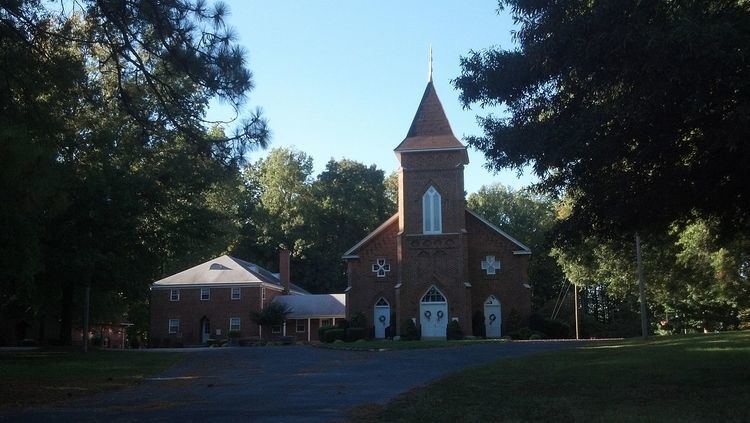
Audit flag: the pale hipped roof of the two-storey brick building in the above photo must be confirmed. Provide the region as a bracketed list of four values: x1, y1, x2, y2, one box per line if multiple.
[151, 255, 308, 294]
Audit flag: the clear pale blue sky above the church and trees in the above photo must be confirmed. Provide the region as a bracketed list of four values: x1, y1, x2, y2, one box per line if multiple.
[209, 0, 533, 192]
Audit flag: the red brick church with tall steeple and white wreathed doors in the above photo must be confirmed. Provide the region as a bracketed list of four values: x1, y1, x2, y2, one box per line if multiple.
[343, 65, 531, 339]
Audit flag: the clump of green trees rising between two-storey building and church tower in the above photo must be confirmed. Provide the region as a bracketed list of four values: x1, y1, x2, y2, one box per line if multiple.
[234, 152, 390, 292]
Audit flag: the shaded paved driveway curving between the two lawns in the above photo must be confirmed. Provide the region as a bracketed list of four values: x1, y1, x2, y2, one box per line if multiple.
[0, 342, 575, 422]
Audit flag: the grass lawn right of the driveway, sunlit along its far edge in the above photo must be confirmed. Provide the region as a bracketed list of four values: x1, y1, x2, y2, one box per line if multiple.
[351, 331, 750, 422]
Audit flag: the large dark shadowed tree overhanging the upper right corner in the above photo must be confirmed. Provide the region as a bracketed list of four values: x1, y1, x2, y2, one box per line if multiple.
[453, 0, 750, 236]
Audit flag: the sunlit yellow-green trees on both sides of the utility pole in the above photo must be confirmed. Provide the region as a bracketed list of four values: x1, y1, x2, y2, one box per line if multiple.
[553, 219, 750, 331]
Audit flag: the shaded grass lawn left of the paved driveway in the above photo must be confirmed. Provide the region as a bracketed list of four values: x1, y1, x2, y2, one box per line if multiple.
[0, 350, 184, 407]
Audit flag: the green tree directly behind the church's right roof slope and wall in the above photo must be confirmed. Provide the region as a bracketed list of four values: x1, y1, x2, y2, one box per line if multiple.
[467, 184, 565, 308]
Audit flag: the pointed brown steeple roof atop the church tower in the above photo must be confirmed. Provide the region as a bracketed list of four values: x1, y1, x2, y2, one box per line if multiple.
[395, 80, 466, 152]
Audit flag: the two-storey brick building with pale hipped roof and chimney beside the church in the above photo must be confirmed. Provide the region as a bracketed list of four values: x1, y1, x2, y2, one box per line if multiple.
[150, 251, 344, 346]
